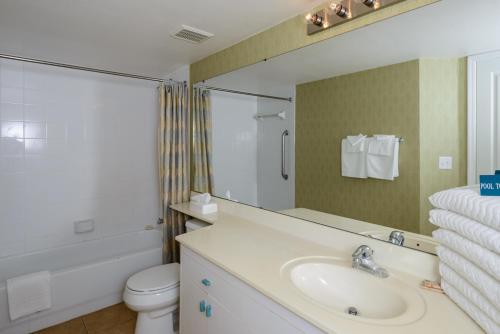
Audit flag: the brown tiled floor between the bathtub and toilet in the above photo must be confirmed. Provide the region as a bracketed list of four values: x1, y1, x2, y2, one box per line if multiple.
[33, 303, 137, 334]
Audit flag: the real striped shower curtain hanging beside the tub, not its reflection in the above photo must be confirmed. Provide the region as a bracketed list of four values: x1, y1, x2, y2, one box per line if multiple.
[158, 83, 190, 263]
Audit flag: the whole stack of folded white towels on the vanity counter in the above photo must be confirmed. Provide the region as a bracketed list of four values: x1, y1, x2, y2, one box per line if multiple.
[429, 187, 500, 334]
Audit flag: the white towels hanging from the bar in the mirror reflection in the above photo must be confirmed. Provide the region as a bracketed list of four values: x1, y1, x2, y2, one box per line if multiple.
[341, 134, 399, 181]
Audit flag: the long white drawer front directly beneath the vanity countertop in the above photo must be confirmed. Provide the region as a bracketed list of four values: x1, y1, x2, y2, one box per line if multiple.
[181, 250, 304, 334]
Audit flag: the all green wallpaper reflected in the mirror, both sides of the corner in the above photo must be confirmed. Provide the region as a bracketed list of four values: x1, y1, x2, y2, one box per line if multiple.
[295, 59, 467, 234]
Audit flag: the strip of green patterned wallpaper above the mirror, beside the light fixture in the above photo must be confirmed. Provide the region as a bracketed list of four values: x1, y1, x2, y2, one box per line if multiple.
[190, 0, 440, 83]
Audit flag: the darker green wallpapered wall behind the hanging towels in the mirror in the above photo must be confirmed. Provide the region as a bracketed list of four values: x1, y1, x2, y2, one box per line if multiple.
[295, 60, 419, 232]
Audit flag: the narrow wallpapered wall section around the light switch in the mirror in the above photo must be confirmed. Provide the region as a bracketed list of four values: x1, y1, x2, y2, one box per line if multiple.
[420, 58, 467, 234]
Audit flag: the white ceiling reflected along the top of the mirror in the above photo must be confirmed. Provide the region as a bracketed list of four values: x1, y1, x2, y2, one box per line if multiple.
[208, 0, 500, 94]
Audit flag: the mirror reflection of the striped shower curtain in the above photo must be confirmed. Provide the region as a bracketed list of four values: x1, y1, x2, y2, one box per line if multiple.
[193, 88, 214, 194]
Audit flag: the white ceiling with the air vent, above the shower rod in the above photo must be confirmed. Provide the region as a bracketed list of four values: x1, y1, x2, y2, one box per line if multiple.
[0, 0, 323, 76]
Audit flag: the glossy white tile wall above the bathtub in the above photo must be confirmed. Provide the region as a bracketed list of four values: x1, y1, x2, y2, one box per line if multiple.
[0, 60, 159, 257]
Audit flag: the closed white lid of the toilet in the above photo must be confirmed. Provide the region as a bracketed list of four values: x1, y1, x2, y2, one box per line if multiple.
[127, 263, 179, 292]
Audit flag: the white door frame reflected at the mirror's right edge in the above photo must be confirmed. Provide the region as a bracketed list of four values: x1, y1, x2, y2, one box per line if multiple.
[467, 51, 500, 185]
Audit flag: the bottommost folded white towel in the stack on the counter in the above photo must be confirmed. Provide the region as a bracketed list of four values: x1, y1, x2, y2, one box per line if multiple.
[441, 280, 500, 334]
